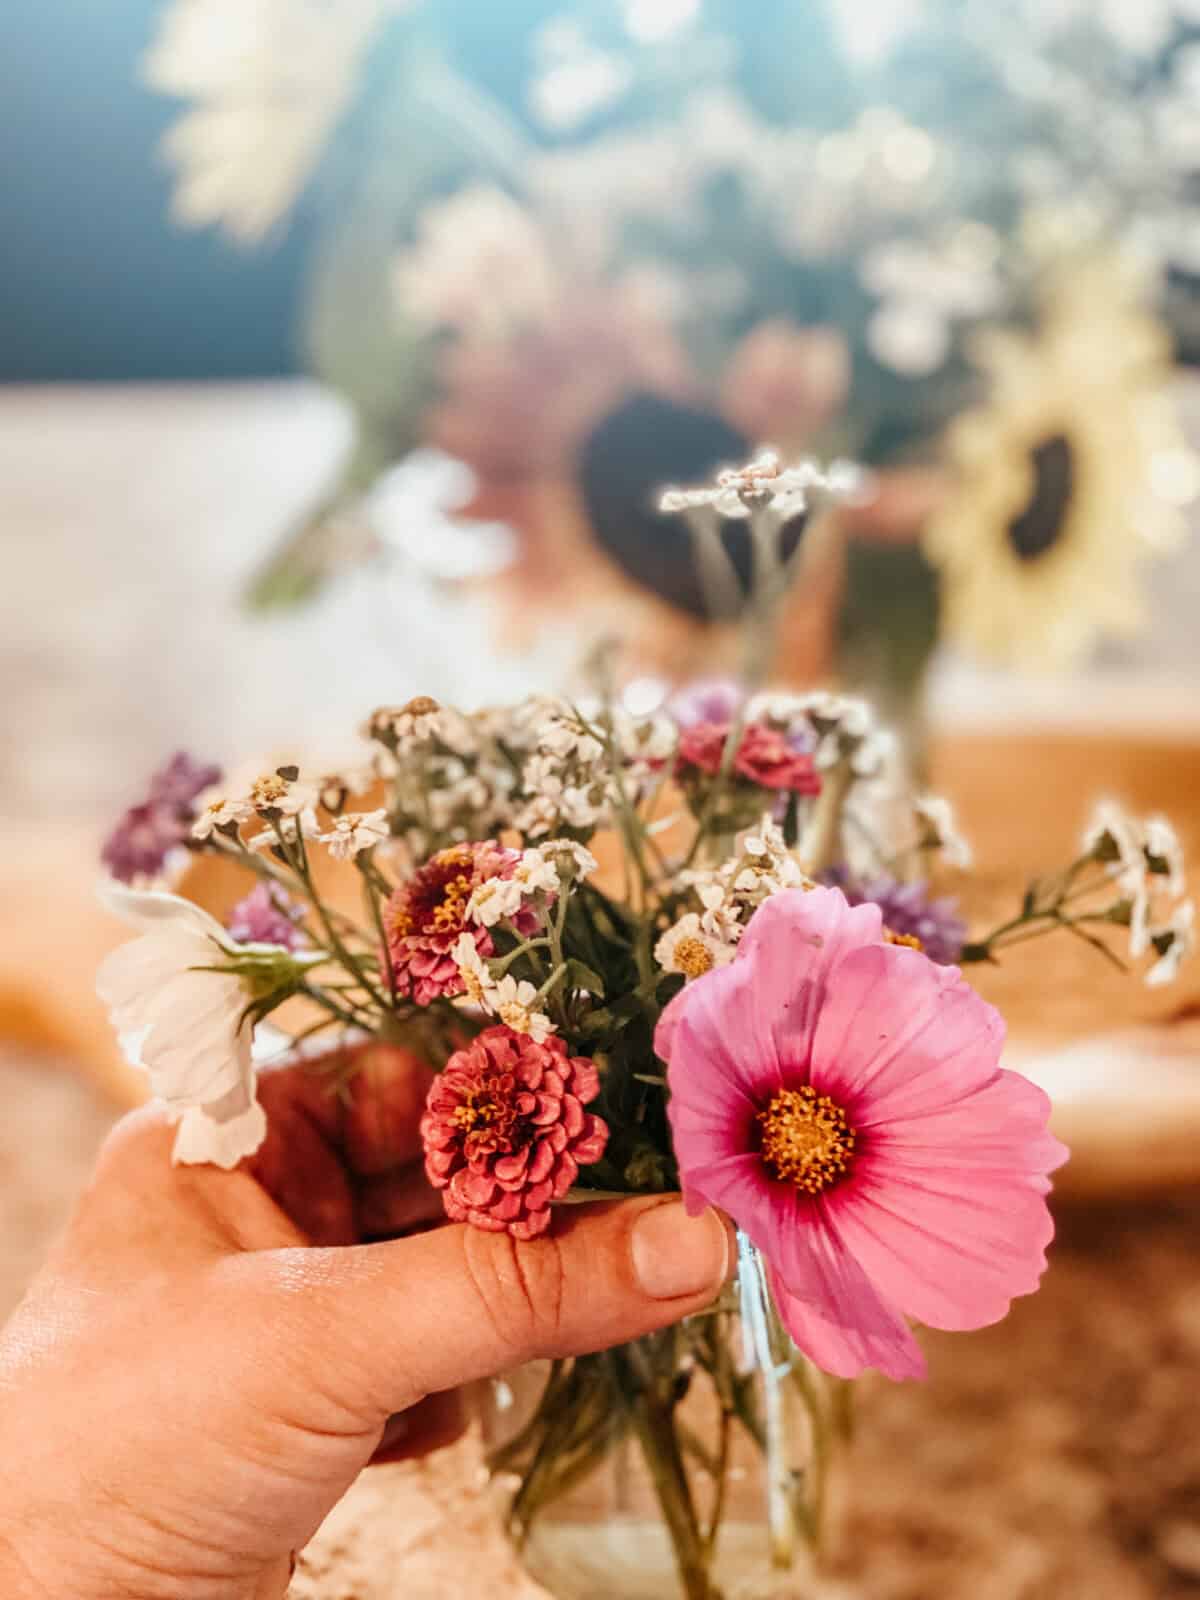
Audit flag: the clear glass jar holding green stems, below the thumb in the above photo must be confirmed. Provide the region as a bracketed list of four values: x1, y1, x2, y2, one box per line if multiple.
[480, 1258, 848, 1600]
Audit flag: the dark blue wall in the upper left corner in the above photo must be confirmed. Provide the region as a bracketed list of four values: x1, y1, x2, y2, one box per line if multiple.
[0, 0, 304, 381]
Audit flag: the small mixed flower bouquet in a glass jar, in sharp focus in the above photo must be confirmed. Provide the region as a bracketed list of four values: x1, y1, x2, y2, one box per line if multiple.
[99, 459, 1192, 1600]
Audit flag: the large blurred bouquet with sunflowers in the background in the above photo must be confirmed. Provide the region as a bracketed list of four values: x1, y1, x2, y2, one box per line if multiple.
[143, 0, 1200, 715]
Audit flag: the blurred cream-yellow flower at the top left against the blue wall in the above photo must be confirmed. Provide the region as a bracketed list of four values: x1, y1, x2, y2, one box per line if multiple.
[142, 0, 410, 240]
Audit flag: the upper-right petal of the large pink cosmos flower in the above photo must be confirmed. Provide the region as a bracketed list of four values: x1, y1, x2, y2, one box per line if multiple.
[811, 944, 1005, 1130]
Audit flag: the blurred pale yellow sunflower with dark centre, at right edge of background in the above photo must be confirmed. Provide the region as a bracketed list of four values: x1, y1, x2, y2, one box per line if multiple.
[923, 256, 1200, 669]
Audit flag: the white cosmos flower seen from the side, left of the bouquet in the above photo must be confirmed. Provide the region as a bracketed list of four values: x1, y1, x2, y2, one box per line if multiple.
[96, 883, 267, 1168]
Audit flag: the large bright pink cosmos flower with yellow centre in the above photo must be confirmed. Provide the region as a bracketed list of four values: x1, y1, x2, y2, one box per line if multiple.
[654, 890, 1067, 1378]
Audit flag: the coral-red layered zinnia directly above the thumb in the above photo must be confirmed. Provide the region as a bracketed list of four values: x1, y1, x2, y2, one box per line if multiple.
[421, 1027, 608, 1238]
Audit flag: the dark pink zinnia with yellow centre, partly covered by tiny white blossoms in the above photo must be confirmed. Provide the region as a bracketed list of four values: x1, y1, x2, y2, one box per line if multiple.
[384, 838, 533, 1005]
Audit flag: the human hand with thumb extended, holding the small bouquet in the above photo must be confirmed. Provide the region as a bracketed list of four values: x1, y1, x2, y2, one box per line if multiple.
[0, 1045, 731, 1600]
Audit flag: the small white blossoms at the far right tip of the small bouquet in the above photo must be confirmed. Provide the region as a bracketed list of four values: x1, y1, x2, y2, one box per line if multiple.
[1083, 800, 1197, 987]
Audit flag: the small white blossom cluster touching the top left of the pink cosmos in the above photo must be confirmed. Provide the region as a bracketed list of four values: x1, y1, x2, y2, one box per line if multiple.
[654, 816, 813, 979]
